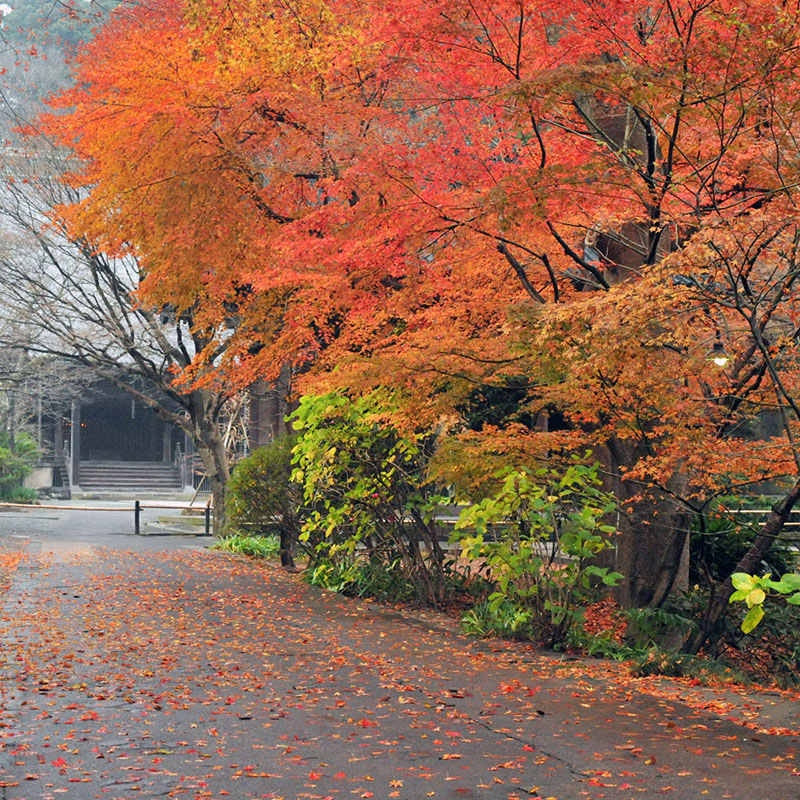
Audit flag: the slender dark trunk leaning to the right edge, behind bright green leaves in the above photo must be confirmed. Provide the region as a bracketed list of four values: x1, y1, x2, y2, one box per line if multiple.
[683, 481, 800, 654]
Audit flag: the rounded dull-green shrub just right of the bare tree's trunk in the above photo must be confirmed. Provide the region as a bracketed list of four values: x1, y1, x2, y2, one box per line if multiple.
[227, 436, 304, 567]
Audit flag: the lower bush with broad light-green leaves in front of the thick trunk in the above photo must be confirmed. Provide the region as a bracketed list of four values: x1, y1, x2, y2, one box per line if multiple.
[453, 459, 622, 647]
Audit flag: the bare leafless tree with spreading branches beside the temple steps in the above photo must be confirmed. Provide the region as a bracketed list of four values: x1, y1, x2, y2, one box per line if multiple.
[0, 144, 252, 532]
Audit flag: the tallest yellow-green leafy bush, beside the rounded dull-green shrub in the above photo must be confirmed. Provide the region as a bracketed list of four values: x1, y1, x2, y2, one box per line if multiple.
[293, 392, 451, 605]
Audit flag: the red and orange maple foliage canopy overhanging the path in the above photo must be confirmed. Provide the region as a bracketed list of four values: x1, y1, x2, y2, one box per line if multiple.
[37, 0, 800, 520]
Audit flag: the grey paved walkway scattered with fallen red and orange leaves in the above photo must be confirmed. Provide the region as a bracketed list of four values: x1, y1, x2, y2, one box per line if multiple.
[0, 512, 800, 800]
